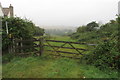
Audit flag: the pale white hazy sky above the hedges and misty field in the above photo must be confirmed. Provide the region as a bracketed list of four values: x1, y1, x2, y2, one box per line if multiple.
[0, 0, 119, 26]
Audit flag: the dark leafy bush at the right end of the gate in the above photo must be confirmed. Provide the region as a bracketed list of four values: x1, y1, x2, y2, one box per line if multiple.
[82, 40, 120, 69]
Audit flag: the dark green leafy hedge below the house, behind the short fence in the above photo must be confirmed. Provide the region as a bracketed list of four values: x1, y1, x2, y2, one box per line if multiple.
[2, 17, 44, 52]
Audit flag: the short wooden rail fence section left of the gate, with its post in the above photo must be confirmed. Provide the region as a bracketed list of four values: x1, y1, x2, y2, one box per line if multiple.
[13, 38, 43, 55]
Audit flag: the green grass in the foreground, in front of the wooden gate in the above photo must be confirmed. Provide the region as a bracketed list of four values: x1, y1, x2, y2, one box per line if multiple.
[3, 55, 117, 78]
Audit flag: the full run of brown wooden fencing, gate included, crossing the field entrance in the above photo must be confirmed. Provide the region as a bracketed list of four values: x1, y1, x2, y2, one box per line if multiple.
[8, 37, 96, 58]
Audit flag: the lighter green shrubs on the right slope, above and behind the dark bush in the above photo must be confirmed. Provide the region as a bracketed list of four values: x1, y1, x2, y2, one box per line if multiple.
[70, 19, 118, 43]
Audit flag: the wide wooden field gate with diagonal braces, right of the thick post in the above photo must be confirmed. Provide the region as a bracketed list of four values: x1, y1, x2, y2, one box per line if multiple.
[44, 40, 96, 59]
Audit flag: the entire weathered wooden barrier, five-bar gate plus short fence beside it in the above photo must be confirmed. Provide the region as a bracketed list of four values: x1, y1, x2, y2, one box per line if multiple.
[14, 37, 96, 59]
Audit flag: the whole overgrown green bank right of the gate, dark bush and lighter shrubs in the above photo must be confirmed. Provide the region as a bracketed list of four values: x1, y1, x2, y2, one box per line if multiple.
[71, 17, 120, 70]
